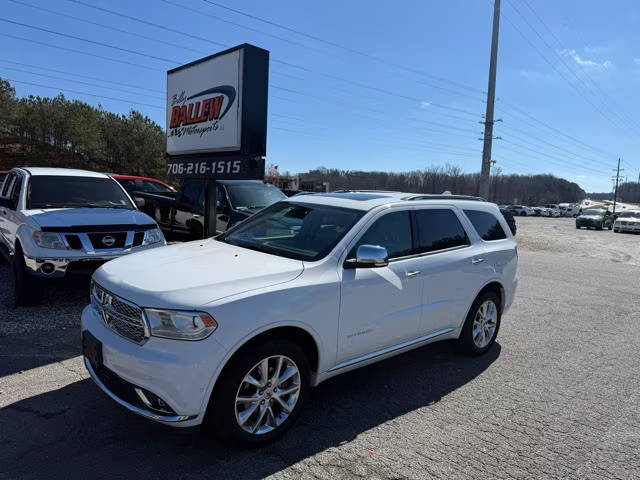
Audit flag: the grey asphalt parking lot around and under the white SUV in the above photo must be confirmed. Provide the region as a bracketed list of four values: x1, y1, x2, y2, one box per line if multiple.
[0, 218, 640, 480]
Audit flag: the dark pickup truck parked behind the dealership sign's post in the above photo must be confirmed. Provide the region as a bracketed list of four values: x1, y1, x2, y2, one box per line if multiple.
[130, 179, 287, 240]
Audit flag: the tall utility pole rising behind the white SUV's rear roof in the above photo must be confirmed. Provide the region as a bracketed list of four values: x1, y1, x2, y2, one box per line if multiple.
[480, 0, 500, 200]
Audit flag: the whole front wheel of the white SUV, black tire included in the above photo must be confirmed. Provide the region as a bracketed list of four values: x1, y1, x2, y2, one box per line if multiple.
[208, 339, 310, 445]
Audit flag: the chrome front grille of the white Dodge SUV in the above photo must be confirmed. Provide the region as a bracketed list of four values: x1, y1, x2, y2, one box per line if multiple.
[91, 282, 149, 344]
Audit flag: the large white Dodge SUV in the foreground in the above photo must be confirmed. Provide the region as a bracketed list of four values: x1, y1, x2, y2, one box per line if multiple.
[82, 192, 517, 443]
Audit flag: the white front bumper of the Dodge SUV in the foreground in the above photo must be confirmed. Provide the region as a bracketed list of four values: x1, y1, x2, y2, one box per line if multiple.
[81, 305, 226, 427]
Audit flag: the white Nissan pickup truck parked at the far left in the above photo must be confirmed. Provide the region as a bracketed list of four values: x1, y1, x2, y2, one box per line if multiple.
[0, 168, 166, 305]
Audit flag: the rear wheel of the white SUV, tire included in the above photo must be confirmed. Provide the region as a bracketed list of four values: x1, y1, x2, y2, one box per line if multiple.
[458, 291, 501, 355]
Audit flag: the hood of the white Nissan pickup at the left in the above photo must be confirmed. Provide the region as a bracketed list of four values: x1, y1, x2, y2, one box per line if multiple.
[25, 208, 156, 228]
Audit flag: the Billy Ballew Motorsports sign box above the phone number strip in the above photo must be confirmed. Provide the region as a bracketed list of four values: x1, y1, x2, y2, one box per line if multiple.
[167, 44, 269, 159]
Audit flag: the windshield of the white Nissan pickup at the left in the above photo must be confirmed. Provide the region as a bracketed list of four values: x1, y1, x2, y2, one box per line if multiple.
[28, 175, 135, 209]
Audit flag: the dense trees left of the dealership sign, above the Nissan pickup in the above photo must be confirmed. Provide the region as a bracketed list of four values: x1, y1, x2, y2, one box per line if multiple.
[0, 78, 166, 178]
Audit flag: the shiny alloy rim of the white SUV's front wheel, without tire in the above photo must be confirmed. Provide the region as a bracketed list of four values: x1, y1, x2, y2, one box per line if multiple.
[235, 355, 300, 435]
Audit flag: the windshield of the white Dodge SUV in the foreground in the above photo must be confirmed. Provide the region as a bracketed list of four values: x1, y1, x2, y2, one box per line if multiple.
[219, 202, 364, 261]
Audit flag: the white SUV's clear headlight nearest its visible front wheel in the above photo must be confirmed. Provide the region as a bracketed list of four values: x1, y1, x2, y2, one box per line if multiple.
[144, 308, 218, 340]
